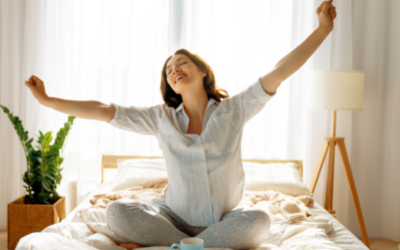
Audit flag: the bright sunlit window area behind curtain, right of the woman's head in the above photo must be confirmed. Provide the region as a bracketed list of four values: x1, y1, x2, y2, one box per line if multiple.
[182, 0, 295, 159]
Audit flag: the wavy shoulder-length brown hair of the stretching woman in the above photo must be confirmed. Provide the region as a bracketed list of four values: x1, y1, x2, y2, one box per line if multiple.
[160, 49, 229, 108]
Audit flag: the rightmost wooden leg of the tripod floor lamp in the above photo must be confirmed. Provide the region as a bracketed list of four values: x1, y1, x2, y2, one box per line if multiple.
[338, 140, 371, 249]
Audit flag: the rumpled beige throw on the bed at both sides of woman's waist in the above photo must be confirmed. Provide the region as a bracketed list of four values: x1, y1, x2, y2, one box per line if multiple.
[90, 178, 314, 222]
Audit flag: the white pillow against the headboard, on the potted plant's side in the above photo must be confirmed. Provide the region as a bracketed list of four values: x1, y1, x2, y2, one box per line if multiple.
[111, 158, 168, 192]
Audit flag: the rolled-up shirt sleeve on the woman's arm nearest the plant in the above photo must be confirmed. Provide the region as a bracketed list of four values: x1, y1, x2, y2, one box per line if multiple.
[108, 103, 160, 135]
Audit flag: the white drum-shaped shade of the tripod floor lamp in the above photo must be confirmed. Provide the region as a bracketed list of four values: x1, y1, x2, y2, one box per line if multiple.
[309, 70, 364, 110]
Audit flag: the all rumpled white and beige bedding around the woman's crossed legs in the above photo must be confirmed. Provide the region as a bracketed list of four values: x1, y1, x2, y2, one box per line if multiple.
[25, 179, 348, 250]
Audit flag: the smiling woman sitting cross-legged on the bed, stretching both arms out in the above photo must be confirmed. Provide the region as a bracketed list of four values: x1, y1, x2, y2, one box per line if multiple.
[25, 0, 336, 249]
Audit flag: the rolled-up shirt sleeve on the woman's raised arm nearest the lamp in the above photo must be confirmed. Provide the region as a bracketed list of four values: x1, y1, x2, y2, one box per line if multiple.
[231, 78, 276, 126]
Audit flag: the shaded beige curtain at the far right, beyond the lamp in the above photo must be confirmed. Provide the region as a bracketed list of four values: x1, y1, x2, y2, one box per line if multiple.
[347, 0, 400, 242]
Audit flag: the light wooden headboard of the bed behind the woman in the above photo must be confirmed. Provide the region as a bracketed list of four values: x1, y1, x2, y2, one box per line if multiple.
[101, 155, 303, 183]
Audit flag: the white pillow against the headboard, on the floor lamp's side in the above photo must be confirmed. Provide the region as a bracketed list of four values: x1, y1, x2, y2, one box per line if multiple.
[243, 162, 311, 197]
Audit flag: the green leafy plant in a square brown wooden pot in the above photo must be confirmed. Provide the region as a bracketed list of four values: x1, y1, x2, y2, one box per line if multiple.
[0, 105, 76, 249]
